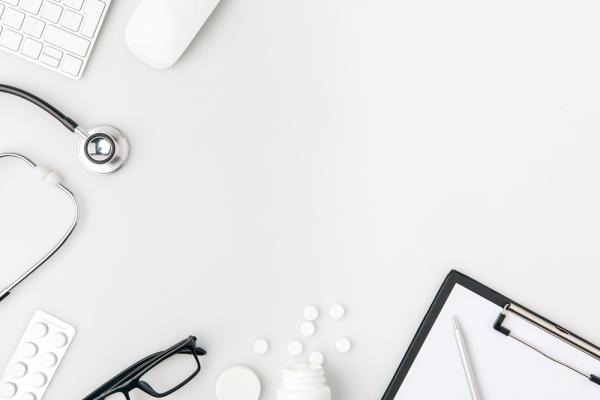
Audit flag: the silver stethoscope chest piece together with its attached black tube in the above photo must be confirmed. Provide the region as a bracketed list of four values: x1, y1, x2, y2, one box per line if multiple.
[0, 84, 129, 174]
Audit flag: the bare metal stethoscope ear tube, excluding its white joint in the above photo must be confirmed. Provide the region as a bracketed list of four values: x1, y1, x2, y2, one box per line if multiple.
[0, 153, 80, 301]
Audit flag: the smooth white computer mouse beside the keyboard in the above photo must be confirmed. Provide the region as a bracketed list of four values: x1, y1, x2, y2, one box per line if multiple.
[125, 0, 220, 69]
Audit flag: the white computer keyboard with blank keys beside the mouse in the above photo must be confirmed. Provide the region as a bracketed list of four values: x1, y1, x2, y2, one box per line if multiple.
[0, 0, 111, 79]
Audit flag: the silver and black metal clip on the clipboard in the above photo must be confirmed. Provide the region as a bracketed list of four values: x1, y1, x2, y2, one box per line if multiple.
[494, 304, 600, 385]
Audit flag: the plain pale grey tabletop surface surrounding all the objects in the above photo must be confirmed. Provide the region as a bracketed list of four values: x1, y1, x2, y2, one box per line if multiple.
[0, 0, 600, 400]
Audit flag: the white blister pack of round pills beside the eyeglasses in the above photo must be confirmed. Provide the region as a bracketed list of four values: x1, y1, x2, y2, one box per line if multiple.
[0, 311, 75, 400]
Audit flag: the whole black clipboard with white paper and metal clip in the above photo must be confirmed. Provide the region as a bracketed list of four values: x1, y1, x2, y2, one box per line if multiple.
[382, 270, 600, 400]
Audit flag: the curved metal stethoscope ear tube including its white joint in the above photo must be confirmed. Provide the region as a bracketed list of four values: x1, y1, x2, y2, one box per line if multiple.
[0, 153, 79, 301]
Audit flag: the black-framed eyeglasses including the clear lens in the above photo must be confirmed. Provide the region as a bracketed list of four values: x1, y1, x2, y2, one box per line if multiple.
[84, 336, 206, 400]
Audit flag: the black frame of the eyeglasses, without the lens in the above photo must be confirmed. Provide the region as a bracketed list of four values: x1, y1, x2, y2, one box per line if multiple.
[84, 336, 206, 400]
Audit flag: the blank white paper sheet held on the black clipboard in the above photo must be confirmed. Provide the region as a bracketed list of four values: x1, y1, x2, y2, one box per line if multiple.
[395, 285, 600, 400]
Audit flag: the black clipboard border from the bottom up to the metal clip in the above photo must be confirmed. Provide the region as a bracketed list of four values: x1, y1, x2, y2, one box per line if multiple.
[382, 270, 513, 400]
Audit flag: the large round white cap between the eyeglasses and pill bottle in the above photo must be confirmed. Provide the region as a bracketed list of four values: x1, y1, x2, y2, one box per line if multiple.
[216, 366, 261, 400]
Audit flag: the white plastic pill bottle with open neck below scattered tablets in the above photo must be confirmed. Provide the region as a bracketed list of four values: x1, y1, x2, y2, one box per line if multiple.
[277, 364, 331, 400]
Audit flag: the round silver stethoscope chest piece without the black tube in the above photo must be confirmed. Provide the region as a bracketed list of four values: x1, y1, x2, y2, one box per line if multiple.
[79, 125, 129, 175]
